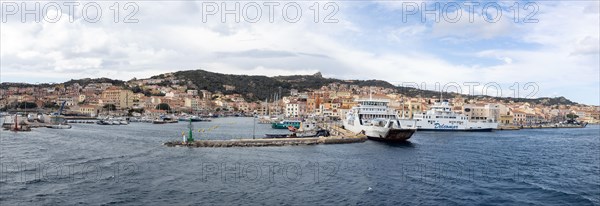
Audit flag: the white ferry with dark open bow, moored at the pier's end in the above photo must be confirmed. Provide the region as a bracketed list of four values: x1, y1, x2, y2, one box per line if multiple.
[343, 99, 416, 141]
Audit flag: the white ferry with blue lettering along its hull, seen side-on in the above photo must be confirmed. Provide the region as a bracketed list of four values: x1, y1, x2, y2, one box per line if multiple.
[401, 100, 498, 132]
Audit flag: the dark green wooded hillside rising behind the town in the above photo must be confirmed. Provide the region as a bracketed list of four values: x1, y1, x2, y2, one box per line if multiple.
[0, 70, 577, 106]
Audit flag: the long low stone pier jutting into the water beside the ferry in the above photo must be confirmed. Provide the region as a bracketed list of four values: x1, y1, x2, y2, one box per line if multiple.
[163, 126, 367, 147]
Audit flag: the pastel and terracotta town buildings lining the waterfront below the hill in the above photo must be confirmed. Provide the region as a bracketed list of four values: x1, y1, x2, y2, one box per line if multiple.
[0, 77, 600, 125]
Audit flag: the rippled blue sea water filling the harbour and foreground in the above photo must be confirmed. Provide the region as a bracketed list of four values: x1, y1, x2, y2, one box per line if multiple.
[0, 118, 600, 205]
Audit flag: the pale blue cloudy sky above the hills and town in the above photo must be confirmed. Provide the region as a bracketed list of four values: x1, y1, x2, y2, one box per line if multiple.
[0, 1, 600, 105]
